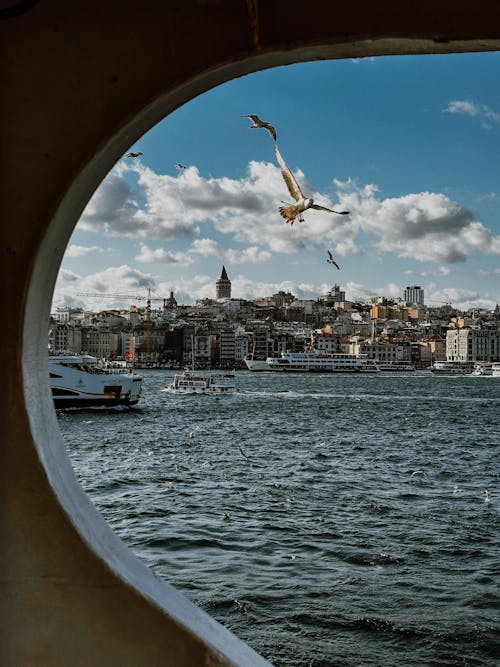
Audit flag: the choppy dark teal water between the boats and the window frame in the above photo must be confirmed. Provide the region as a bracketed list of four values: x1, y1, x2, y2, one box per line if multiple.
[59, 371, 500, 667]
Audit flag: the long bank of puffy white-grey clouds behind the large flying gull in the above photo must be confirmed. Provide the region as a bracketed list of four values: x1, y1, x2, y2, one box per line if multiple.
[74, 161, 500, 274]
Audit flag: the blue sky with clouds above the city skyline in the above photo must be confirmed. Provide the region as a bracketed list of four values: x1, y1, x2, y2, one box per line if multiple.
[53, 53, 500, 309]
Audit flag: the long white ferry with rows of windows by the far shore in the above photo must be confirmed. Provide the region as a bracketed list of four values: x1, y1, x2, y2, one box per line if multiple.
[266, 350, 380, 373]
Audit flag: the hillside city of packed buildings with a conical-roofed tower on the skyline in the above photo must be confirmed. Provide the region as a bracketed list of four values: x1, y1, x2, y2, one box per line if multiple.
[48, 267, 500, 369]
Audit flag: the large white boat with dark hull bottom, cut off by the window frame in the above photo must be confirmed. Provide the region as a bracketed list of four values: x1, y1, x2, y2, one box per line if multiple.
[49, 354, 142, 409]
